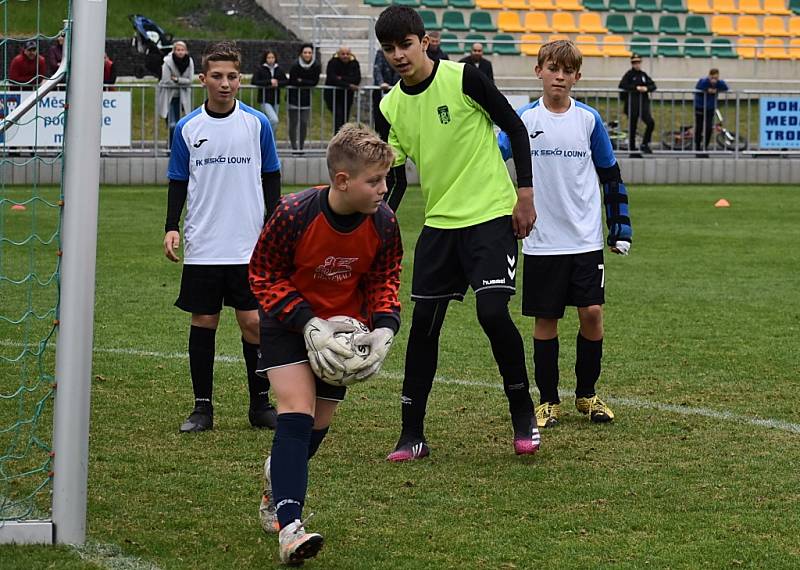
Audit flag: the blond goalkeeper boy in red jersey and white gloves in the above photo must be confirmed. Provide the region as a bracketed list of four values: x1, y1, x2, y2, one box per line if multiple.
[250, 124, 403, 564]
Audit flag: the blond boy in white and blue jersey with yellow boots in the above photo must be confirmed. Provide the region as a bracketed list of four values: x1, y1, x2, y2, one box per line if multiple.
[499, 40, 632, 428]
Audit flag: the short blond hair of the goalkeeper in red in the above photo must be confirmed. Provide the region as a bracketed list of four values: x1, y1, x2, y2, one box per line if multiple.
[326, 123, 394, 181]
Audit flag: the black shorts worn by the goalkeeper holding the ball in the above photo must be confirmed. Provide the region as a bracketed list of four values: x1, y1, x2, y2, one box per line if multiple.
[256, 326, 347, 402]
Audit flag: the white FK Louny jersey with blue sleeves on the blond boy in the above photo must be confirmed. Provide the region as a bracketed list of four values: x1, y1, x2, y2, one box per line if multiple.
[499, 98, 616, 255]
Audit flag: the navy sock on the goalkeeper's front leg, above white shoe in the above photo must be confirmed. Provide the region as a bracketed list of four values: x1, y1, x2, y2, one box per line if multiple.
[270, 413, 314, 528]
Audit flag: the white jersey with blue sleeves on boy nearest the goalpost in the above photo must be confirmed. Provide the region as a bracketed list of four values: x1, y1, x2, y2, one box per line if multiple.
[167, 101, 280, 265]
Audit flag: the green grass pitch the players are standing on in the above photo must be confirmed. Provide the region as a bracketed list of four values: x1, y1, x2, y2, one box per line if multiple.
[0, 186, 800, 570]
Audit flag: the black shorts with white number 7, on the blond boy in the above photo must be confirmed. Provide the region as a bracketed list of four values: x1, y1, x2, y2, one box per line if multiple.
[522, 249, 605, 319]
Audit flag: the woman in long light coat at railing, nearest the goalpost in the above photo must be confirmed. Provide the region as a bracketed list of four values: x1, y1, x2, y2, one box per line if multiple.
[156, 41, 194, 148]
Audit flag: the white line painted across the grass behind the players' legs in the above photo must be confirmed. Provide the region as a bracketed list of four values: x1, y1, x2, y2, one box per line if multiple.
[87, 348, 800, 434]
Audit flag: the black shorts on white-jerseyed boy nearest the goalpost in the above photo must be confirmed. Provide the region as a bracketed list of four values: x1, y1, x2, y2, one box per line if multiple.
[175, 264, 258, 315]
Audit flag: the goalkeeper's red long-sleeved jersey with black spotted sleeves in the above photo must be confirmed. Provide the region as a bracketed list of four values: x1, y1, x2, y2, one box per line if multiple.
[250, 186, 403, 330]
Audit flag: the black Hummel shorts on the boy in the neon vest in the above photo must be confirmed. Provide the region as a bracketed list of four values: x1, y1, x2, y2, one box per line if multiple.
[411, 216, 518, 301]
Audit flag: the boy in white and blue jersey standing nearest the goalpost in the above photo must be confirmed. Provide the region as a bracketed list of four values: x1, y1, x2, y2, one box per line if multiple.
[164, 42, 280, 432]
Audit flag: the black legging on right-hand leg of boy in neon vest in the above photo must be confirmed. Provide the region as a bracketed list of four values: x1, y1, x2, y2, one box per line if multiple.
[476, 293, 533, 417]
